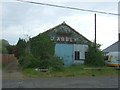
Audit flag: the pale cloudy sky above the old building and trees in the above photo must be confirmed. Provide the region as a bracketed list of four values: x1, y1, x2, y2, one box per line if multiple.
[0, 0, 118, 49]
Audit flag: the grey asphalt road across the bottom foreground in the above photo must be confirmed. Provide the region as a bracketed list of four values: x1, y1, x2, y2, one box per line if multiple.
[2, 76, 118, 88]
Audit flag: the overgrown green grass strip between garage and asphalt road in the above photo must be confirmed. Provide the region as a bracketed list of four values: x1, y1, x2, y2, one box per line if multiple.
[22, 65, 119, 78]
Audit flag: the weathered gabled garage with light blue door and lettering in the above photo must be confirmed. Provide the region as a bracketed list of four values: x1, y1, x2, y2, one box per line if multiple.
[44, 22, 91, 66]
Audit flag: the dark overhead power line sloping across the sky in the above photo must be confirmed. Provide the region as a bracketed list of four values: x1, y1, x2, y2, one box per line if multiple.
[17, 0, 120, 16]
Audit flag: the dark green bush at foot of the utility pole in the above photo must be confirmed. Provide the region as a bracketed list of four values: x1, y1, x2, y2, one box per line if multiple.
[85, 43, 105, 67]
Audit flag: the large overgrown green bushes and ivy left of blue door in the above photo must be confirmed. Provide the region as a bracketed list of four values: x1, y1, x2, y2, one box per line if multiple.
[17, 34, 63, 70]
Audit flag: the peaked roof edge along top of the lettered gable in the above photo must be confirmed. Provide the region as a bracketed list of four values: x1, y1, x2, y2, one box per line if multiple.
[44, 22, 91, 43]
